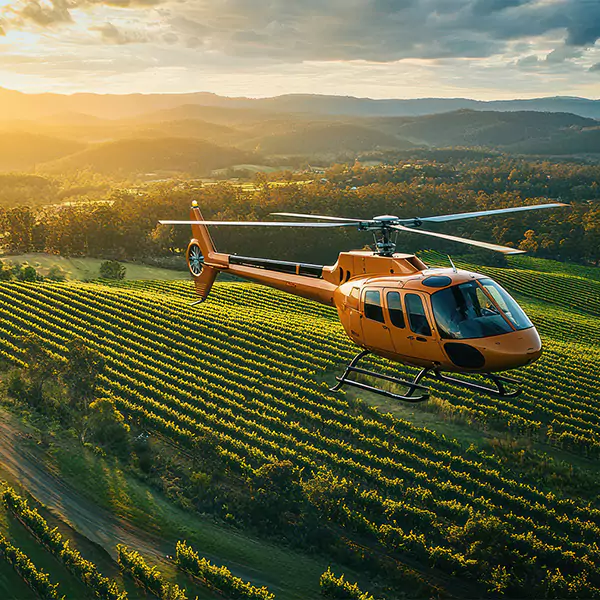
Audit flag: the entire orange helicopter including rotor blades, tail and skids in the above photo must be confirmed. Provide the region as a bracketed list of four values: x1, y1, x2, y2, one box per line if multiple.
[160, 200, 568, 403]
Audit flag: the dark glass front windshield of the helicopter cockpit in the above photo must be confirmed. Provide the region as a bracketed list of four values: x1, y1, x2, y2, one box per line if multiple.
[431, 279, 533, 339]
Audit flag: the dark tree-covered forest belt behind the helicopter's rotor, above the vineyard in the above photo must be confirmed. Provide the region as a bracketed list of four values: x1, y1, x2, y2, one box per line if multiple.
[0, 156, 600, 264]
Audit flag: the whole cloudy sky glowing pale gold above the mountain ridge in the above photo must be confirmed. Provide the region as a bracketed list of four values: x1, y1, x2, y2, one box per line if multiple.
[0, 0, 600, 100]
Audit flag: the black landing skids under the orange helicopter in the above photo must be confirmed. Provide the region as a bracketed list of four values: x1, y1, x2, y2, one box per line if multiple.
[329, 350, 521, 403]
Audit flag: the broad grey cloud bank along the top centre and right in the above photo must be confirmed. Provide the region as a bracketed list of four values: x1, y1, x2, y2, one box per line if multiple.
[155, 0, 600, 62]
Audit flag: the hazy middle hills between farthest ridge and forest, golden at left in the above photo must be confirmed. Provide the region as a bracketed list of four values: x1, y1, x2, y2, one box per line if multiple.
[0, 104, 600, 176]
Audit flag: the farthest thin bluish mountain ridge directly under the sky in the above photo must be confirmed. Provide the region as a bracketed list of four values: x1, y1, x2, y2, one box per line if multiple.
[0, 88, 600, 121]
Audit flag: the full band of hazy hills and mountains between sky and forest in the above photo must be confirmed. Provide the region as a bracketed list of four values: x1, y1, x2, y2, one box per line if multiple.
[0, 89, 600, 176]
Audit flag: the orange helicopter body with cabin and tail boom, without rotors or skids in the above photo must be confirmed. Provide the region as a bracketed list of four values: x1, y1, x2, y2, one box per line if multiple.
[193, 230, 541, 373]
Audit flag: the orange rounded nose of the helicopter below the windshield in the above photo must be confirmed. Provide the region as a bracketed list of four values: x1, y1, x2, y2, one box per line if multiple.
[480, 327, 542, 371]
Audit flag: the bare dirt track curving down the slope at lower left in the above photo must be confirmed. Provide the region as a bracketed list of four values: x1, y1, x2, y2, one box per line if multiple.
[0, 410, 172, 560]
